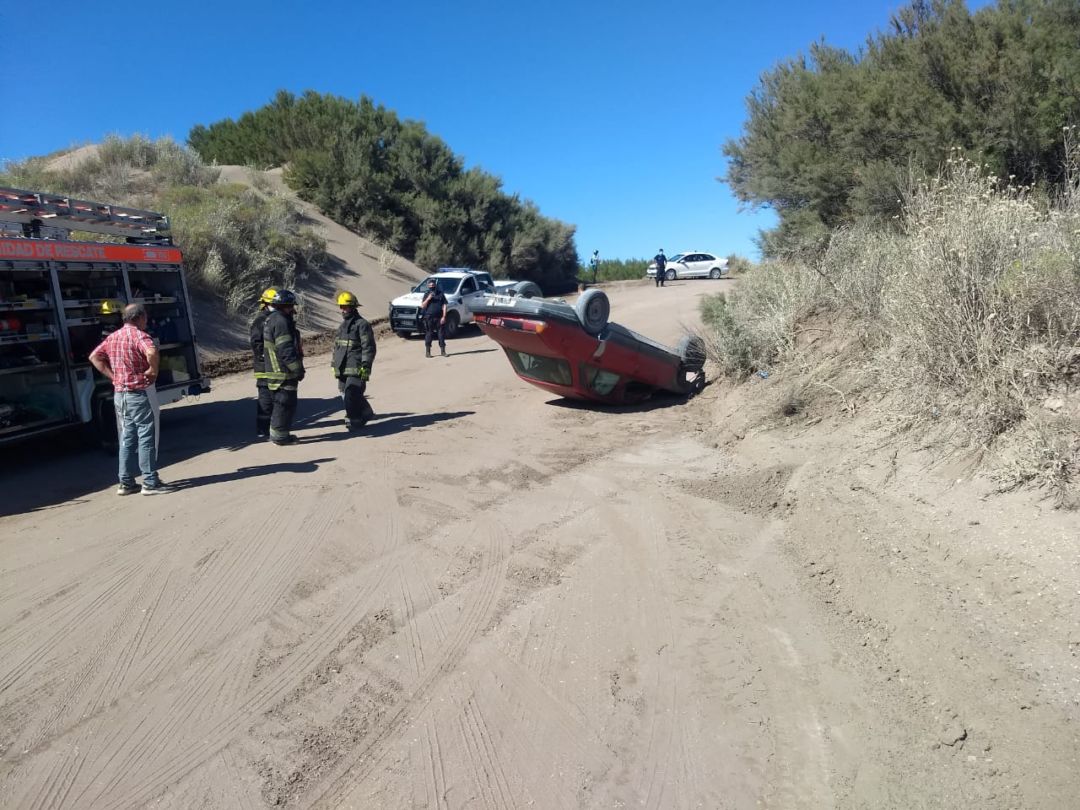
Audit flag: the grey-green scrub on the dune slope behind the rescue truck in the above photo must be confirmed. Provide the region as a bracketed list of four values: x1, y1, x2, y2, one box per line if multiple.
[0, 135, 326, 310]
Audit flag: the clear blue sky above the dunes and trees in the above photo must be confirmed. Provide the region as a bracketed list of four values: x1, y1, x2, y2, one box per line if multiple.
[0, 0, 988, 260]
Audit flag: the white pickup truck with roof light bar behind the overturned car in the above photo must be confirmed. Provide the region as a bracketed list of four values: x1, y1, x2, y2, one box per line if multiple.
[390, 267, 540, 338]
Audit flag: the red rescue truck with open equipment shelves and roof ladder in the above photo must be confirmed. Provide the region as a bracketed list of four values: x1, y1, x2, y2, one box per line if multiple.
[0, 187, 210, 445]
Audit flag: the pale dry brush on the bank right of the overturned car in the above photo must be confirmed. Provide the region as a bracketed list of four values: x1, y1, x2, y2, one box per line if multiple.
[702, 145, 1080, 498]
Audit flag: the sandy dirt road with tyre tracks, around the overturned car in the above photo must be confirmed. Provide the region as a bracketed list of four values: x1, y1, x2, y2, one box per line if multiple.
[0, 281, 1077, 809]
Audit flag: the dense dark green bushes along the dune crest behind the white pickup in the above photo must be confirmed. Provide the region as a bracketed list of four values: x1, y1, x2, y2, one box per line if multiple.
[188, 91, 578, 288]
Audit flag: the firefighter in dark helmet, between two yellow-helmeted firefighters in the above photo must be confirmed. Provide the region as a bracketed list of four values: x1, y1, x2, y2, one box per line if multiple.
[262, 289, 303, 445]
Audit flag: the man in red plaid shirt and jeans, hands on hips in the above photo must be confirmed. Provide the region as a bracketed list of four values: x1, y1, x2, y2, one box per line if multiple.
[90, 303, 174, 495]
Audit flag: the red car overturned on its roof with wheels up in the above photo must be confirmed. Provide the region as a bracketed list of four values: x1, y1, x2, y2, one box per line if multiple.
[471, 289, 705, 404]
